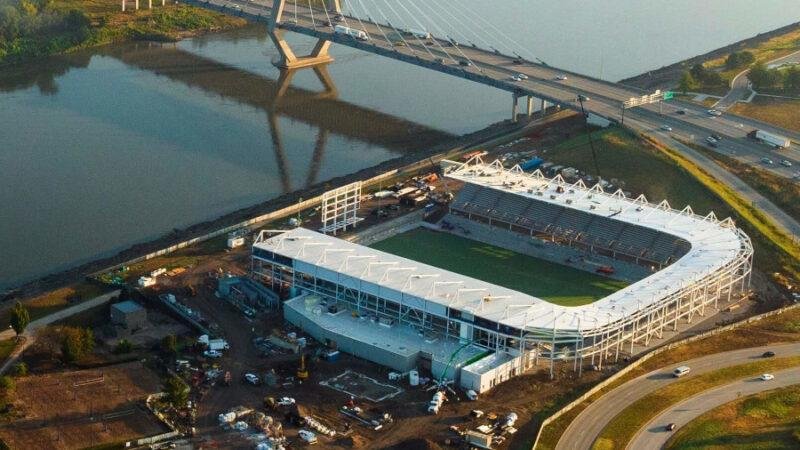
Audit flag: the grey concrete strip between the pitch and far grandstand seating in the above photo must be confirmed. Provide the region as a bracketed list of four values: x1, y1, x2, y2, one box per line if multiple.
[444, 214, 652, 282]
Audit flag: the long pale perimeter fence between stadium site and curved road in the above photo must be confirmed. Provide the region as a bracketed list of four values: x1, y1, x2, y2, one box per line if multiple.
[531, 303, 800, 450]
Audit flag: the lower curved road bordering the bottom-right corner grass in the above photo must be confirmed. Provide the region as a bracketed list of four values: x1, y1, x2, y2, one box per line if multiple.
[626, 367, 800, 450]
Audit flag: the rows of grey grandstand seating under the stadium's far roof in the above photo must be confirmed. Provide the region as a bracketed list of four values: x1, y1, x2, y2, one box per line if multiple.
[451, 183, 690, 264]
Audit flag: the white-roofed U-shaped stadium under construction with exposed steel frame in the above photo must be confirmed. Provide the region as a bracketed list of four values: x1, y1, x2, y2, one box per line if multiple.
[252, 157, 753, 392]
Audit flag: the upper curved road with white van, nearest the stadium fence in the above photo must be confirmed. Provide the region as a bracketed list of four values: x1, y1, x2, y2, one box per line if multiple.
[556, 343, 800, 450]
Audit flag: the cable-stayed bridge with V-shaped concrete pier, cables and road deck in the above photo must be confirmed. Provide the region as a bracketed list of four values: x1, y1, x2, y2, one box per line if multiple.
[188, 0, 800, 176]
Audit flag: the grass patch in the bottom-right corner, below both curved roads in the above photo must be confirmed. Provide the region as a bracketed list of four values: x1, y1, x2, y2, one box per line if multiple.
[667, 386, 800, 450]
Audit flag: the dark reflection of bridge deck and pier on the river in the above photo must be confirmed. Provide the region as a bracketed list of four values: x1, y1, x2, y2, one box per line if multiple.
[103, 43, 454, 192]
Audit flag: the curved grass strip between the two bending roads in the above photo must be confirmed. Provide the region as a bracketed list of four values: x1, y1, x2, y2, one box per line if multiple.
[593, 357, 800, 450]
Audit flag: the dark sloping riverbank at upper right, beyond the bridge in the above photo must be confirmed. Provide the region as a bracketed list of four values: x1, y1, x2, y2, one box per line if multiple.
[620, 22, 800, 91]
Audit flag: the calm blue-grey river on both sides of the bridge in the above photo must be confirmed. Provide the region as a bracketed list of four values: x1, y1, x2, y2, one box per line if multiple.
[0, 0, 800, 289]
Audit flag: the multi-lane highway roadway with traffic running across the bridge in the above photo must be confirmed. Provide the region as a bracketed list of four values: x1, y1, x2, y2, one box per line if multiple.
[197, 0, 800, 180]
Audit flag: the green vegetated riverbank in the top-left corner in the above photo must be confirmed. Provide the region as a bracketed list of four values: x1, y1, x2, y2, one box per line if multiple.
[0, 0, 247, 67]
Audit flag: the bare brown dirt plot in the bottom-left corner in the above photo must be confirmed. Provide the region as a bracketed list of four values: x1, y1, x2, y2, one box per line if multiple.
[0, 362, 168, 449]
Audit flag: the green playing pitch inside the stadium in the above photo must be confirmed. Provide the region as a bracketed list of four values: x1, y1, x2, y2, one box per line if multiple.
[371, 228, 628, 306]
